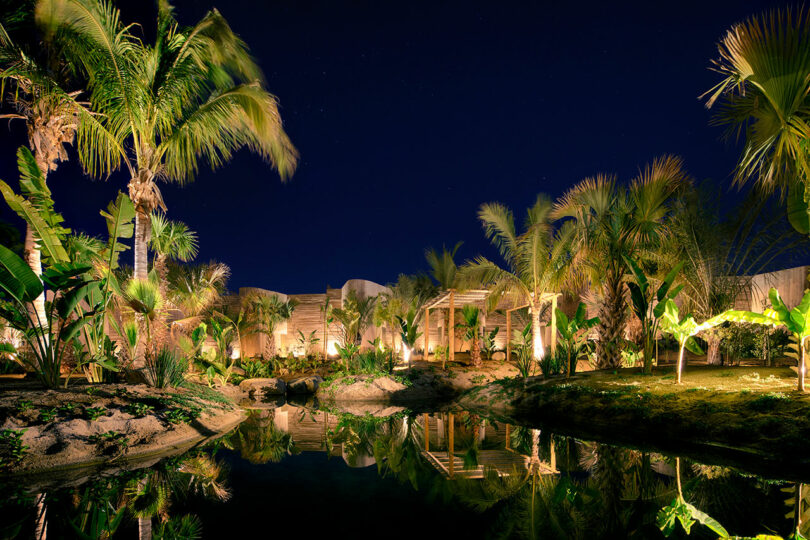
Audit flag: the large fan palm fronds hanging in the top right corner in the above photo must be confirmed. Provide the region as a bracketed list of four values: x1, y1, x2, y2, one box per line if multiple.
[704, 7, 810, 207]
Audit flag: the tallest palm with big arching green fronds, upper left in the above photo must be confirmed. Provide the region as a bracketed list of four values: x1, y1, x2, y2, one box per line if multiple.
[37, 0, 298, 279]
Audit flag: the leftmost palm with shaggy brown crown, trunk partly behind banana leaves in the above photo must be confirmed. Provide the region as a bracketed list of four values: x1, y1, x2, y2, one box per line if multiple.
[0, 6, 120, 330]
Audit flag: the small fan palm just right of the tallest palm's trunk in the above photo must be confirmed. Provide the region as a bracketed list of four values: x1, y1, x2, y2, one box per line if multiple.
[150, 213, 197, 347]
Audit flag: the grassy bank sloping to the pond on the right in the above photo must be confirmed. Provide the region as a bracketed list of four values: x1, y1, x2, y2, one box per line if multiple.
[462, 366, 810, 478]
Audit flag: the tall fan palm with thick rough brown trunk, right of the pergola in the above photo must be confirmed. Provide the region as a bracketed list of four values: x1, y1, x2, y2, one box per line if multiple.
[551, 156, 690, 368]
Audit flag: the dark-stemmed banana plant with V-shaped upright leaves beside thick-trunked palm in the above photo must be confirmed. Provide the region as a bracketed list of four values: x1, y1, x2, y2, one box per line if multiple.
[622, 255, 684, 374]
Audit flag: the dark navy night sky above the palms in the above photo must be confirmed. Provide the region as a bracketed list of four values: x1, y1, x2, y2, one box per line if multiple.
[0, 0, 784, 293]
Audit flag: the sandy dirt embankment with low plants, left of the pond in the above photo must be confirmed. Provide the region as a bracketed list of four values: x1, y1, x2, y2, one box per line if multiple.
[0, 384, 245, 474]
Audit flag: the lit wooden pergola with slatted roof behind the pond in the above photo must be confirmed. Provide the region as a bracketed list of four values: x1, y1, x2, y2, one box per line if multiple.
[424, 289, 562, 362]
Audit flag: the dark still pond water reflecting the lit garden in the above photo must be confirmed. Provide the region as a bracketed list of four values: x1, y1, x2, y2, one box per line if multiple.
[0, 405, 810, 539]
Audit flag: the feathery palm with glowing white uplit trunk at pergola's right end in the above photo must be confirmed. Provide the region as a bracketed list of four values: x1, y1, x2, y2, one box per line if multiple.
[459, 195, 569, 362]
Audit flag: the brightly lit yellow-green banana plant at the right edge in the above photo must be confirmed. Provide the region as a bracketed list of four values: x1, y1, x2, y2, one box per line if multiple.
[722, 288, 810, 392]
